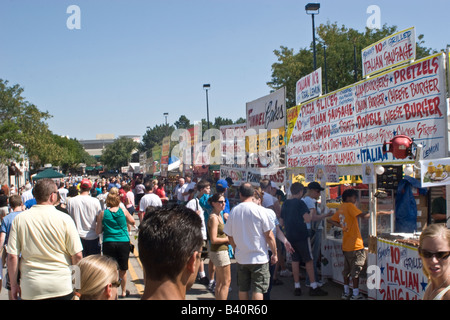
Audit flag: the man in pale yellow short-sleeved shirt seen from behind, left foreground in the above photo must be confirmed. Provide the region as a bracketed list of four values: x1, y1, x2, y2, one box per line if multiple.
[7, 179, 83, 300]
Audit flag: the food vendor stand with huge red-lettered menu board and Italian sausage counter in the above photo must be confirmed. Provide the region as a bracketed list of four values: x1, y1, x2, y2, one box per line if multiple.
[287, 29, 448, 300]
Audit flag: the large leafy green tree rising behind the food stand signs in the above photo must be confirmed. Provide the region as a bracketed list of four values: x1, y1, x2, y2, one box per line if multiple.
[267, 22, 433, 108]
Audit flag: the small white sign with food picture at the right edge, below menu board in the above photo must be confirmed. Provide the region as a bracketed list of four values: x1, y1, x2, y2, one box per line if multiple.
[419, 158, 450, 188]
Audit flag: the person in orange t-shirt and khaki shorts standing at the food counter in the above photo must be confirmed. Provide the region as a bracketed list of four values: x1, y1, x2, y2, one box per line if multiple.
[328, 189, 370, 300]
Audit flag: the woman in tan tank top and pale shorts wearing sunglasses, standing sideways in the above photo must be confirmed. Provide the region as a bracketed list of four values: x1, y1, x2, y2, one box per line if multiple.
[208, 193, 231, 300]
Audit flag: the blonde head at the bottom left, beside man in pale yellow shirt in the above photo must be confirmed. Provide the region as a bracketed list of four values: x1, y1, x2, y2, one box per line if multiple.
[73, 254, 120, 300]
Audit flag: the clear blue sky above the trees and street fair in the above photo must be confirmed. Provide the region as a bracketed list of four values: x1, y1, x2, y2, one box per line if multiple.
[0, 0, 450, 140]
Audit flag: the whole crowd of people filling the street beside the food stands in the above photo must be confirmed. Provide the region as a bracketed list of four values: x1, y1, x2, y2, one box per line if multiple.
[0, 172, 450, 300]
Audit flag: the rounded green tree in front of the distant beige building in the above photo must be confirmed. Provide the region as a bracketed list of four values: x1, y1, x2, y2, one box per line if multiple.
[100, 137, 139, 169]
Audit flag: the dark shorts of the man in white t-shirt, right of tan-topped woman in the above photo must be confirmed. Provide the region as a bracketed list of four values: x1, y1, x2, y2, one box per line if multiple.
[237, 262, 270, 293]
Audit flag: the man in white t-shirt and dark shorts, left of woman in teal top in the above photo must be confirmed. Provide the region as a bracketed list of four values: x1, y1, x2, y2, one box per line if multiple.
[67, 179, 102, 257]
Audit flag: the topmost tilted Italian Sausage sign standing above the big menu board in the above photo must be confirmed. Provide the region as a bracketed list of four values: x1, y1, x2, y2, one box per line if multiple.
[361, 27, 416, 77]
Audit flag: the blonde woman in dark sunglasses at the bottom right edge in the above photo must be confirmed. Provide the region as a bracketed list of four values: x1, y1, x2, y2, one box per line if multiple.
[418, 223, 450, 300]
